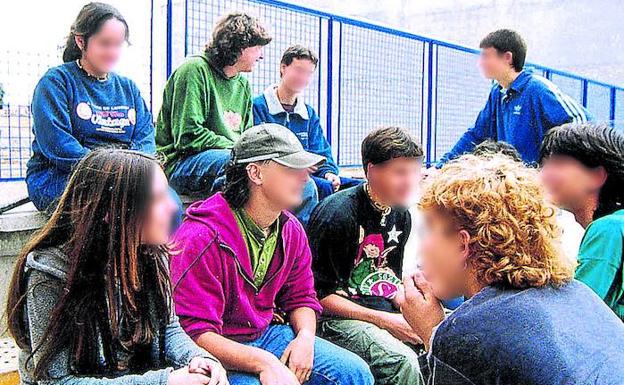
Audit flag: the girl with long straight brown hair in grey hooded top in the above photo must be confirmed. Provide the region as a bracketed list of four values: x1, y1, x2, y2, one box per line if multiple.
[7, 149, 227, 385]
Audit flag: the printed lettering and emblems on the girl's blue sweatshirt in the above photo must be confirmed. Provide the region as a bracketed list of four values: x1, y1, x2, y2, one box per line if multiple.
[76, 102, 136, 134]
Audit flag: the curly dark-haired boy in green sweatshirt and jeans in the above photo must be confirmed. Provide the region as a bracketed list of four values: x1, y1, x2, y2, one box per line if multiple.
[156, 13, 271, 197]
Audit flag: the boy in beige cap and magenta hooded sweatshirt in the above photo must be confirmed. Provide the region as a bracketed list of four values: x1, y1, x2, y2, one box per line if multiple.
[171, 124, 373, 385]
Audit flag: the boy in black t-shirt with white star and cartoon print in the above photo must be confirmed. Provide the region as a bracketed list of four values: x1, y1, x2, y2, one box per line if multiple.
[308, 127, 423, 385]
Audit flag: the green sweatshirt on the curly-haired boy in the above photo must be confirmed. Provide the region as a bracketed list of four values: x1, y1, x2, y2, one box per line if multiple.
[156, 55, 253, 174]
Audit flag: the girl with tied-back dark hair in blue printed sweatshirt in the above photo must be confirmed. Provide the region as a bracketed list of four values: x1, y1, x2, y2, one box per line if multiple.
[26, 3, 156, 211]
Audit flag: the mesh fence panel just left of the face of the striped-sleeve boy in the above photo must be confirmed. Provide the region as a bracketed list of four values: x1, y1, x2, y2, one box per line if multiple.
[432, 46, 492, 161]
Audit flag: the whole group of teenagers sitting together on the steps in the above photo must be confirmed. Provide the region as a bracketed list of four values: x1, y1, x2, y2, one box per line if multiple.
[7, 3, 624, 385]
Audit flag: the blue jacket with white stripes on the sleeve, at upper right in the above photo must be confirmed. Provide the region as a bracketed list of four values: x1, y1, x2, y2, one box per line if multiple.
[439, 70, 592, 166]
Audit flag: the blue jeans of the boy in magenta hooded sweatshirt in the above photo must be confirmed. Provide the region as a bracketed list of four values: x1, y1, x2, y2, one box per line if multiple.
[228, 325, 373, 385]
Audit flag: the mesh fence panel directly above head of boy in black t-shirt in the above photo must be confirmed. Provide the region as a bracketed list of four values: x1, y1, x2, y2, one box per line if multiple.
[338, 25, 424, 165]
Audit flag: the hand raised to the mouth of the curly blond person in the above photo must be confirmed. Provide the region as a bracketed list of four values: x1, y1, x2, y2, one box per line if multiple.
[401, 272, 444, 350]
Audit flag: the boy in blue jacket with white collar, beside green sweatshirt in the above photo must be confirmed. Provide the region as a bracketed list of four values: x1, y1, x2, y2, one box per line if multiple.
[253, 45, 362, 200]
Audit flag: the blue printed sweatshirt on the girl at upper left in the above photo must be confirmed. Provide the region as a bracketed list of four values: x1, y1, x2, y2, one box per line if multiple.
[26, 62, 156, 209]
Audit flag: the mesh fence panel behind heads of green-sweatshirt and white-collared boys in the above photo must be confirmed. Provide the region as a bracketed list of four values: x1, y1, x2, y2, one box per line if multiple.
[186, 0, 326, 110]
